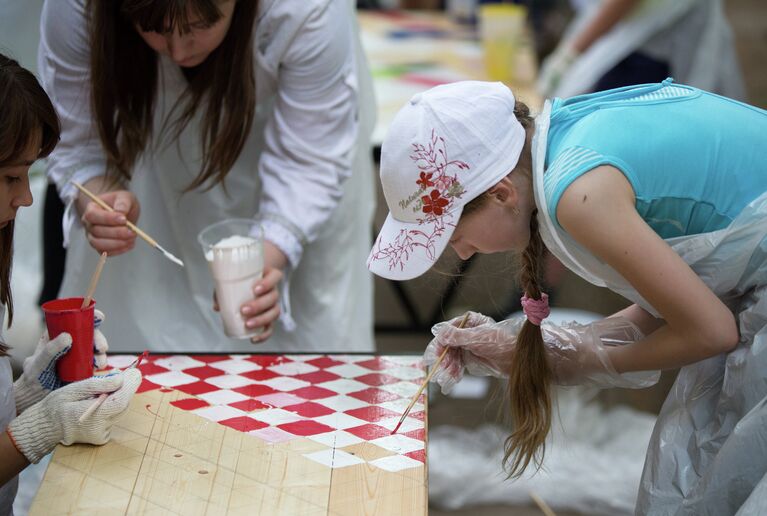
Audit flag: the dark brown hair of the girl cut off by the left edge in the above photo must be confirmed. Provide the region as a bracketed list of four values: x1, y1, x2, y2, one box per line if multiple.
[0, 54, 60, 346]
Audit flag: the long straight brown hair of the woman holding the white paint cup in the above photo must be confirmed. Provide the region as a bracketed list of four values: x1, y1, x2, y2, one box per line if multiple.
[89, 0, 258, 191]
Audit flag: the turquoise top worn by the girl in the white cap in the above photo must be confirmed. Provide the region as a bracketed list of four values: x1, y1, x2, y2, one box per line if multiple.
[544, 79, 767, 238]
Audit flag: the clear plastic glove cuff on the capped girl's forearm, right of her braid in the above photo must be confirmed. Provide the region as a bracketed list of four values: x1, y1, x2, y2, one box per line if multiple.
[541, 317, 660, 389]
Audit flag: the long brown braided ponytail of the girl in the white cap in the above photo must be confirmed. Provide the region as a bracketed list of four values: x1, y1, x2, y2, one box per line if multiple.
[463, 101, 551, 478]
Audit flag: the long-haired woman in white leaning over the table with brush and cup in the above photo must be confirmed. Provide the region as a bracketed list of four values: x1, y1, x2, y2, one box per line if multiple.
[39, 0, 373, 351]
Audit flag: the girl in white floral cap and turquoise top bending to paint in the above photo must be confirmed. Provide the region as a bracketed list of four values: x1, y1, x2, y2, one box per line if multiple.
[368, 80, 767, 514]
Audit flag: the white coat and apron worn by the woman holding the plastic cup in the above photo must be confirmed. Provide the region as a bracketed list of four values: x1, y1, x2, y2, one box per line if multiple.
[38, 0, 374, 351]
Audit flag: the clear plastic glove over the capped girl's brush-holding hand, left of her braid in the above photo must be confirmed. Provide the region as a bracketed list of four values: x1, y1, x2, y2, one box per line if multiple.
[423, 312, 525, 394]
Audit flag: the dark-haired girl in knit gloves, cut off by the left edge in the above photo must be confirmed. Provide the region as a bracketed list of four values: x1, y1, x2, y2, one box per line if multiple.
[0, 54, 141, 514]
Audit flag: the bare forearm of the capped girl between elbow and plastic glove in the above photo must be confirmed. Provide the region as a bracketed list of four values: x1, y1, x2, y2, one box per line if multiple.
[607, 325, 724, 373]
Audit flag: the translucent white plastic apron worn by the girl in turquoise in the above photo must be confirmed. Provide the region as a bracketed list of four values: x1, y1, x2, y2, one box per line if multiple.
[533, 94, 767, 516]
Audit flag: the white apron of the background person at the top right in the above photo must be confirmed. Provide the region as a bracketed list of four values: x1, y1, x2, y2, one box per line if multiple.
[551, 0, 745, 100]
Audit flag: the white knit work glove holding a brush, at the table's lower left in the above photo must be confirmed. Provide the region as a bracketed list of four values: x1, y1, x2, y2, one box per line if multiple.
[7, 369, 141, 463]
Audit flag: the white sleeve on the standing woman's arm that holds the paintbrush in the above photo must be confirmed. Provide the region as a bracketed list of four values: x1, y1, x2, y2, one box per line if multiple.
[37, 0, 112, 247]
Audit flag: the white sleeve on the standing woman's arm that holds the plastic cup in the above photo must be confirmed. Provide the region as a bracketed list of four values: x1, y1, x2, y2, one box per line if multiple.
[258, 1, 358, 269]
